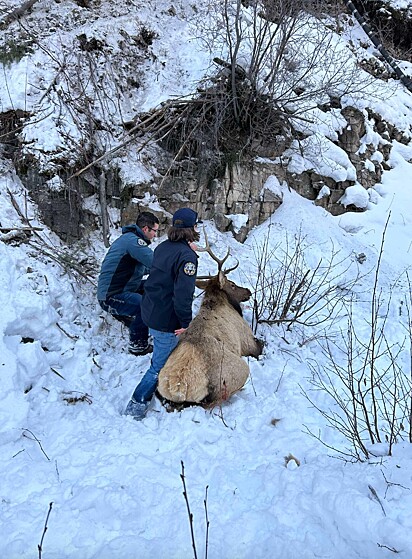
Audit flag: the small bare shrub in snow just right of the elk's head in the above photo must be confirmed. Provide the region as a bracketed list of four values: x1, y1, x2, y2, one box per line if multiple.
[249, 226, 360, 332]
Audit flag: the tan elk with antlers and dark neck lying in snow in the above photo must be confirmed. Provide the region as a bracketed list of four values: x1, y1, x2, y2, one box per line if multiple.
[157, 233, 263, 404]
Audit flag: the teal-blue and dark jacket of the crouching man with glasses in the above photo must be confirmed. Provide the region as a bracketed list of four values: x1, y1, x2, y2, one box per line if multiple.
[97, 225, 153, 301]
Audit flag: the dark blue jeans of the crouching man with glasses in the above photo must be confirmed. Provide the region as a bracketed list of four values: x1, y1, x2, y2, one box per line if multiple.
[99, 291, 149, 346]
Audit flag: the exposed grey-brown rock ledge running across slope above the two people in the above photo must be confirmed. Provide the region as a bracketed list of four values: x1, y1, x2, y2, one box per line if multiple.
[0, 101, 410, 243]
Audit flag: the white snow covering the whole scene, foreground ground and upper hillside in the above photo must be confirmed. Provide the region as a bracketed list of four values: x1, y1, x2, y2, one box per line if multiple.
[0, 0, 412, 559]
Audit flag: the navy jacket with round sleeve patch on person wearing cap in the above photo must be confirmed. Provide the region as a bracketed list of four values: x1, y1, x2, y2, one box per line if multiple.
[142, 241, 198, 332]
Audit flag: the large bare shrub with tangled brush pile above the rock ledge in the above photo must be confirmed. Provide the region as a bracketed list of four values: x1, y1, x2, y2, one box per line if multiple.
[73, 0, 374, 184]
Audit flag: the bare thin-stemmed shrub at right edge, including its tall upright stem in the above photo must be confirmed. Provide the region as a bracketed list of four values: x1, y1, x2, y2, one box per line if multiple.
[302, 221, 412, 460]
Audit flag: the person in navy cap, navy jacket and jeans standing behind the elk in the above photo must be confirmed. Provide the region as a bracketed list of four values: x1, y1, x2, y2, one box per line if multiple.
[125, 208, 199, 420]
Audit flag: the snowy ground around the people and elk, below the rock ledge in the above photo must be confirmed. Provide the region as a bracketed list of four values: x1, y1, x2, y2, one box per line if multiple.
[0, 145, 412, 559]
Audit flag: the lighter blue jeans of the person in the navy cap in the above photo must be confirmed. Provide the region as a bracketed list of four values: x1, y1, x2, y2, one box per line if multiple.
[132, 328, 178, 403]
